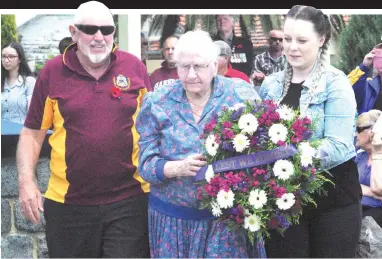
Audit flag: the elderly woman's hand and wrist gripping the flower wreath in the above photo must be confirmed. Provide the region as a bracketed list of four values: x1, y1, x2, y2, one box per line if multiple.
[164, 154, 207, 178]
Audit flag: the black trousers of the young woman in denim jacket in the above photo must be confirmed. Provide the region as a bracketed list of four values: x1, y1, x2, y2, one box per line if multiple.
[265, 202, 361, 258]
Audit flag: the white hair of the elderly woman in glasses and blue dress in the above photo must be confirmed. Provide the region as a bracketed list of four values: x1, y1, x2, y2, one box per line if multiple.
[174, 30, 220, 62]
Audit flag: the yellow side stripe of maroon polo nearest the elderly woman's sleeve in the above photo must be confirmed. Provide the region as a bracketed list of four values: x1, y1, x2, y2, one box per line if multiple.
[131, 88, 150, 192]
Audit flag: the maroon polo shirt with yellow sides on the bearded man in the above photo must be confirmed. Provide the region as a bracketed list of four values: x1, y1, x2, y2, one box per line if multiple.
[25, 44, 151, 205]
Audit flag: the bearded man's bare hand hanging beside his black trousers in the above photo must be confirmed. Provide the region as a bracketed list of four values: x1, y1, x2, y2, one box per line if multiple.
[19, 179, 44, 224]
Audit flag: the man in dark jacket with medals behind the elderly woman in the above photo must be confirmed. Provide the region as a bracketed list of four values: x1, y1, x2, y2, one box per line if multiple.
[212, 15, 253, 76]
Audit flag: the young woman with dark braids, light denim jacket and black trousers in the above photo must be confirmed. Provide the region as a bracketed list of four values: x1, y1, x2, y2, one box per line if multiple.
[260, 5, 362, 258]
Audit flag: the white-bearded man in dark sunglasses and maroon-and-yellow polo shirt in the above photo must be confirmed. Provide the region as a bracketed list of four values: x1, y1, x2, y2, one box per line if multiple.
[17, 1, 151, 258]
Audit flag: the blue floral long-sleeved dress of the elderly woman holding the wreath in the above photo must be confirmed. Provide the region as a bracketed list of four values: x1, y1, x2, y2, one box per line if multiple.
[136, 76, 265, 258]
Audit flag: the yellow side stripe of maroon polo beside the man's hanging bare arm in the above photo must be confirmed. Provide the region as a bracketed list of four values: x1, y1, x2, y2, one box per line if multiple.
[43, 97, 69, 203]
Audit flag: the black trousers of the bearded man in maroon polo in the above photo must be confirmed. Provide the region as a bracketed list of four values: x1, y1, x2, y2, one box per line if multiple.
[44, 194, 150, 258]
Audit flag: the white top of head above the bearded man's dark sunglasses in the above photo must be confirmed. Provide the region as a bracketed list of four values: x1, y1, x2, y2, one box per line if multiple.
[74, 1, 115, 25]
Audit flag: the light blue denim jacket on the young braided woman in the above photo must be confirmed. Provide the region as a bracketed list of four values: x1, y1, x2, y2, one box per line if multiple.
[260, 65, 357, 169]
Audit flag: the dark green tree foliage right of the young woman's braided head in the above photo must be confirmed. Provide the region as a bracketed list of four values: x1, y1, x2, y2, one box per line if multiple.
[334, 15, 382, 74]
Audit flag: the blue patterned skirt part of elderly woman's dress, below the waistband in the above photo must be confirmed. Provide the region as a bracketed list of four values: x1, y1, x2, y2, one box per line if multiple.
[148, 207, 266, 258]
